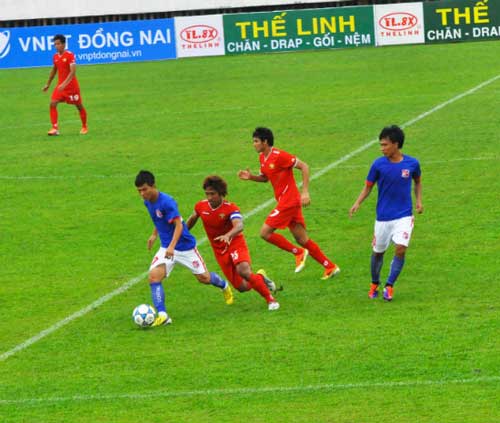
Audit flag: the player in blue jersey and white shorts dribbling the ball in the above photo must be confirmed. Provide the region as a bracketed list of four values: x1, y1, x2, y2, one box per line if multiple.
[135, 170, 233, 326]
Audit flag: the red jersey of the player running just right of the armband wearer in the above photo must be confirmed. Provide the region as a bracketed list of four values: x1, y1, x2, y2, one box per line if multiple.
[259, 147, 301, 208]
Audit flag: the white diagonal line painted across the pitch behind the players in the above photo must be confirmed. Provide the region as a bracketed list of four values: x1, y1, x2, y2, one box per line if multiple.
[0, 74, 500, 362]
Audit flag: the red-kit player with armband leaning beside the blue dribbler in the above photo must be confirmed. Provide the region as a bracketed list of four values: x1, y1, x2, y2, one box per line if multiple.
[186, 175, 280, 311]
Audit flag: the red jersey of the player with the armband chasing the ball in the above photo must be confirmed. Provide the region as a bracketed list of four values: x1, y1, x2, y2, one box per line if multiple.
[194, 200, 244, 253]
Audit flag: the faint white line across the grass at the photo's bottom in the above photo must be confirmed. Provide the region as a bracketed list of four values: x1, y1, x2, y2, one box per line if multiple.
[0, 376, 500, 405]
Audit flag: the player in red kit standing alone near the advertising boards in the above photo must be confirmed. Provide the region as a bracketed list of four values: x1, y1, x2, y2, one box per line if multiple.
[42, 34, 88, 135]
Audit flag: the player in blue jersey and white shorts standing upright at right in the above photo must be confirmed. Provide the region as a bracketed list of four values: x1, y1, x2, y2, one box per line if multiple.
[349, 125, 424, 301]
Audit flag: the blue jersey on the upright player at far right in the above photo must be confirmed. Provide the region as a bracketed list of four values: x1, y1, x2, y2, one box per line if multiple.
[366, 155, 420, 221]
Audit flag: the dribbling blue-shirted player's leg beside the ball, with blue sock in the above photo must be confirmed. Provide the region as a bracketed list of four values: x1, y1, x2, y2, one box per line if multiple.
[149, 248, 174, 326]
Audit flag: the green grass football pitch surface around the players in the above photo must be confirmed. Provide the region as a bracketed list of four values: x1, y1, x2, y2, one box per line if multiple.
[0, 42, 500, 423]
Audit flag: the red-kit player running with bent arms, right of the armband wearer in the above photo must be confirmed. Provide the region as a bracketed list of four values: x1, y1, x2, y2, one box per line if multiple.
[238, 128, 340, 279]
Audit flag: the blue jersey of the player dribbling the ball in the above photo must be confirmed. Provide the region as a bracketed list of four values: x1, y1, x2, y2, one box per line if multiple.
[144, 192, 196, 251]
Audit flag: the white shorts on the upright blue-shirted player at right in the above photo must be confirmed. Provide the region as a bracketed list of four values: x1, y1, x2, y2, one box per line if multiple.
[372, 216, 414, 253]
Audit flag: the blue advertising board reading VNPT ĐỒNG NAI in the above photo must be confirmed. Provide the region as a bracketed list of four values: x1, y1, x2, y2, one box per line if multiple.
[0, 19, 176, 68]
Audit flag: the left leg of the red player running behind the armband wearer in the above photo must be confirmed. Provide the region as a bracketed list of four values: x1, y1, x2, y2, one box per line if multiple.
[260, 207, 308, 272]
